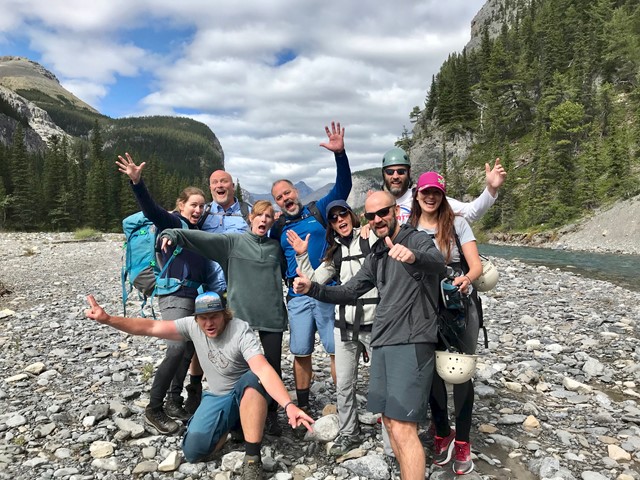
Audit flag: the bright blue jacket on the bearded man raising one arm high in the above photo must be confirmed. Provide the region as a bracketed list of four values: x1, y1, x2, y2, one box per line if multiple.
[268, 151, 351, 296]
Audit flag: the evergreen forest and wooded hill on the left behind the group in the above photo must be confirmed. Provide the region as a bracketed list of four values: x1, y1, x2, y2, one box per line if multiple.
[0, 119, 223, 232]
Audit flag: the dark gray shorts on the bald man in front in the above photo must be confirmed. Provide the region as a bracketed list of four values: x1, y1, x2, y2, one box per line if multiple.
[367, 343, 436, 423]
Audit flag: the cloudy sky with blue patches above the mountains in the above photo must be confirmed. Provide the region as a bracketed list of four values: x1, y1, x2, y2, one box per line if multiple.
[0, 0, 484, 193]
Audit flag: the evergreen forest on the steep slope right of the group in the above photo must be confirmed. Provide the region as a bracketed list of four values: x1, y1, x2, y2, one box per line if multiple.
[397, 0, 640, 232]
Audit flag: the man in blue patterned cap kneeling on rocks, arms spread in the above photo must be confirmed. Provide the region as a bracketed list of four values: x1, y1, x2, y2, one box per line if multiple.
[85, 292, 313, 479]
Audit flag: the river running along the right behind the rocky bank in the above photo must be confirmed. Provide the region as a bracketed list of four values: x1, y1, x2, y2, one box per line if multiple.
[478, 243, 640, 290]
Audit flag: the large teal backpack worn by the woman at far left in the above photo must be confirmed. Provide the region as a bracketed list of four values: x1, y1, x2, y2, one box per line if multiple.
[120, 212, 201, 318]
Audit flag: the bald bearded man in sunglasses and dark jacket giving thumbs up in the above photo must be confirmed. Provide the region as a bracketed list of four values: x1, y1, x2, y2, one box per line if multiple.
[294, 192, 445, 480]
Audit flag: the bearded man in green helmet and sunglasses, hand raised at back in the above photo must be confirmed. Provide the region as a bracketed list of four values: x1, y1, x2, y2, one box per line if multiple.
[382, 148, 507, 224]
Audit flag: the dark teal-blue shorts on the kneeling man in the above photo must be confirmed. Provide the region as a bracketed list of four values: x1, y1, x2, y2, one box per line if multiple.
[182, 371, 269, 463]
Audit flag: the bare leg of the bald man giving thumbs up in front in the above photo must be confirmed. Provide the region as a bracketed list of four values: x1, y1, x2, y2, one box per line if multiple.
[382, 415, 426, 480]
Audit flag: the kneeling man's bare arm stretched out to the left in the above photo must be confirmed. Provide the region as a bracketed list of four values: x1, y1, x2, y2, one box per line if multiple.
[85, 295, 184, 341]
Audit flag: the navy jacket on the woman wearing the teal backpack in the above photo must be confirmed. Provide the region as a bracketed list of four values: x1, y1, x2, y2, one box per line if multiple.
[131, 179, 227, 298]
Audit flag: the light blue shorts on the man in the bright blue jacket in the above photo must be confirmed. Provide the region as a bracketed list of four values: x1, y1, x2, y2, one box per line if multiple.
[287, 296, 336, 356]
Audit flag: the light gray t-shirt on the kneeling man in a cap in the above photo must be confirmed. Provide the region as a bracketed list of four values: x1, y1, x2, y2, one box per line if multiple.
[176, 317, 262, 395]
